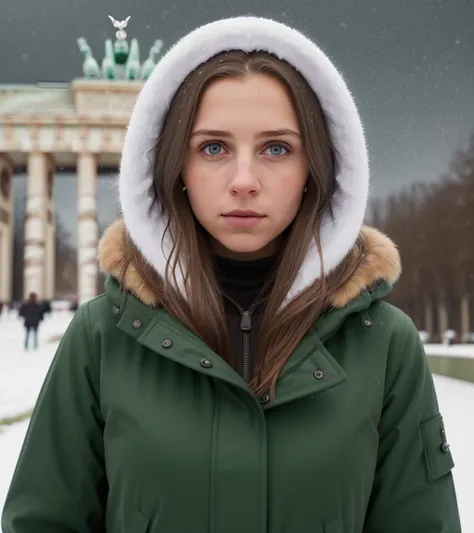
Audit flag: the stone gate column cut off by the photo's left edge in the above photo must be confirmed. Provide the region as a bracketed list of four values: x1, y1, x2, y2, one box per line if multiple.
[0, 155, 14, 302]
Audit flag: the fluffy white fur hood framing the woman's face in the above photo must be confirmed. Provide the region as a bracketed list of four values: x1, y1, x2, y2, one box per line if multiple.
[119, 17, 369, 301]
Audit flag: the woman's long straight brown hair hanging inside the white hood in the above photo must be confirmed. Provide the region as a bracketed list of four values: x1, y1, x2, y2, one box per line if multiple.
[121, 51, 363, 395]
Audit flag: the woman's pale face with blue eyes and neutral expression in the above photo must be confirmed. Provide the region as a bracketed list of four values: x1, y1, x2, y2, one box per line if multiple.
[182, 74, 308, 259]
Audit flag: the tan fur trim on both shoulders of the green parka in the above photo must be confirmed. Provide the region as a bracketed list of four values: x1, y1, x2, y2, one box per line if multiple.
[99, 219, 401, 308]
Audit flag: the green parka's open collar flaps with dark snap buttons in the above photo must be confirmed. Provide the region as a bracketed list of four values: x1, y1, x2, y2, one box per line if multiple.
[106, 276, 350, 409]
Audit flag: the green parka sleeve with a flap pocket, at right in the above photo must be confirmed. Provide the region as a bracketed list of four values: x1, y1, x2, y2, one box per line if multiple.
[363, 317, 461, 533]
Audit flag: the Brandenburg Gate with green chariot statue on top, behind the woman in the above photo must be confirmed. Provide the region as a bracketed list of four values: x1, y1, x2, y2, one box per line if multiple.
[0, 19, 162, 303]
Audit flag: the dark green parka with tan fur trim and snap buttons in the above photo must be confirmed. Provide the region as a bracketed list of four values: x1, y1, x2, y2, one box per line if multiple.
[2, 218, 460, 533]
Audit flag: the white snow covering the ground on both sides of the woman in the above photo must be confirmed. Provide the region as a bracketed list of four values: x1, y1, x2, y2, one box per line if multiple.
[0, 311, 474, 532]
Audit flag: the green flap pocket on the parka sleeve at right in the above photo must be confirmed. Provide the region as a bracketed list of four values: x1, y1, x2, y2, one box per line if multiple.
[420, 415, 454, 483]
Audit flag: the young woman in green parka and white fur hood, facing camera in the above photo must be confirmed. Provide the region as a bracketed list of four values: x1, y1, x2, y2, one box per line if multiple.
[2, 17, 460, 533]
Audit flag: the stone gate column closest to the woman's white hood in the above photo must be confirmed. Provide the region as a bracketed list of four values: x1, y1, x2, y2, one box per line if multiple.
[77, 153, 99, 304]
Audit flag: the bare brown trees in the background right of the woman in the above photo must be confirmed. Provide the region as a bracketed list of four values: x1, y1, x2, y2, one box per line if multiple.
[372, 135, 474, 338]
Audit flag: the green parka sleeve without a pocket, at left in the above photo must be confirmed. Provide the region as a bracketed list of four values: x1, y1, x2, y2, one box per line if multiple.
[2, 304, 107, 533]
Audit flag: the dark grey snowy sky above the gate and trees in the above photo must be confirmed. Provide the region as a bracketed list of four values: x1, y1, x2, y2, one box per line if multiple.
[0, 0, 474, 237]
